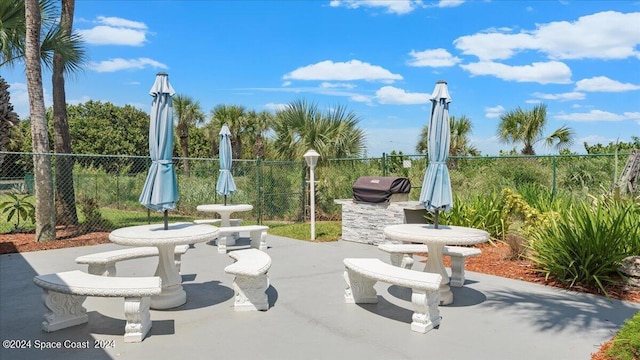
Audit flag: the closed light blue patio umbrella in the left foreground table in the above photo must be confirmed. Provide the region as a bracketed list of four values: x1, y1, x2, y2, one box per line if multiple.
[139, 72, 179, 229]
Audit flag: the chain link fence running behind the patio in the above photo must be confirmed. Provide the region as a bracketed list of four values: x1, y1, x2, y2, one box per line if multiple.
[0, 152, 627, 234]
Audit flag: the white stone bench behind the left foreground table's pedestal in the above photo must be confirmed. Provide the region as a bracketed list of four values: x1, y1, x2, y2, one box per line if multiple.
[76, 245, 189, 276]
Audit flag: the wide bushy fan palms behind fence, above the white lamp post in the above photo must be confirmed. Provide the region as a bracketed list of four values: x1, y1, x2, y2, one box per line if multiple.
[274, 100, 365, 160]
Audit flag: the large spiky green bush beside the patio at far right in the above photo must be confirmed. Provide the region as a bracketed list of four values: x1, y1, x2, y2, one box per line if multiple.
[530, 199, 640, 294]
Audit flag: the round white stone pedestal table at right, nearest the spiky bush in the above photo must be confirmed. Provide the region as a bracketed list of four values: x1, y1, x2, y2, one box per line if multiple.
[384, 224, 489, 305]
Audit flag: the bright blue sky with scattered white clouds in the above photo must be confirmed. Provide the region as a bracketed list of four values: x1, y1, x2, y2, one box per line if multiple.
[2, 0, 640, 156]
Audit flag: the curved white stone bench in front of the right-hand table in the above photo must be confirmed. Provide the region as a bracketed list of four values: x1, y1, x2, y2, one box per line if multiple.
[344, 258, 442, 334]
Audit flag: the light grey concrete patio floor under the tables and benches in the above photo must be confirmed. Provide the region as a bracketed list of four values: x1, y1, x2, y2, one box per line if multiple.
[0, 235, 640, 360]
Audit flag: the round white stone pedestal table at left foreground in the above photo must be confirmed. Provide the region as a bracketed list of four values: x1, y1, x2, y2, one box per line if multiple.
[109, 223, 219, 310]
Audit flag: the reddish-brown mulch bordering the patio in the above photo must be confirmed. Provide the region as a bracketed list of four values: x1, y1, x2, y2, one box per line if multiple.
[0, 227, 640, 360]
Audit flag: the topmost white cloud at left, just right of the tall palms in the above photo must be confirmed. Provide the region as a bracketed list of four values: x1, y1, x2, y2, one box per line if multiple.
[78, 16, 147, 46]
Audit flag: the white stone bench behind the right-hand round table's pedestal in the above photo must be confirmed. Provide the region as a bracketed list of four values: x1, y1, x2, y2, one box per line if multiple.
[378, 243, 481, 287]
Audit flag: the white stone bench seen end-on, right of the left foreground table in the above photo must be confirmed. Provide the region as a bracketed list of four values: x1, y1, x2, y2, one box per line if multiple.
[224, 249, 271, 311]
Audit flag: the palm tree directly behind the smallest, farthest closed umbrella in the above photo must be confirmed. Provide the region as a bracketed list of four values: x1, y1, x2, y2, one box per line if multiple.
[210, 105, 247, 159]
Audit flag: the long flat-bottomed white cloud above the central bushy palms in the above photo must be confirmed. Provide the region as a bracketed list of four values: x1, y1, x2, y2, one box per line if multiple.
[283, 60, 402, 82]
